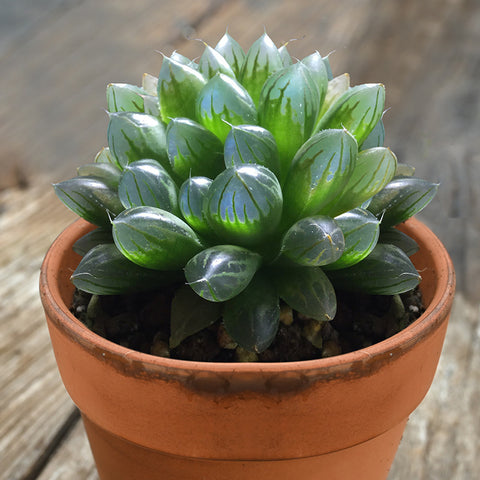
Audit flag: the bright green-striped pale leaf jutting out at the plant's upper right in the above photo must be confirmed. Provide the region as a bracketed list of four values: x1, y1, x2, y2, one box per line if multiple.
[315, 83, 385, 145]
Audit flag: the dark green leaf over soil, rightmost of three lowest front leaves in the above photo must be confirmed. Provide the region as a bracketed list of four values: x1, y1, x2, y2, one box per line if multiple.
[272, 267, 337, 321]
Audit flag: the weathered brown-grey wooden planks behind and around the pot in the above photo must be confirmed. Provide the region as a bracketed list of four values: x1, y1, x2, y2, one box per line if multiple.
[0, 0, 480, 480]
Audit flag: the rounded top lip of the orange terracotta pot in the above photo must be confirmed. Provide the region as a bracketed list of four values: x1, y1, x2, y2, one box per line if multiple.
[40, 218, 455, 375]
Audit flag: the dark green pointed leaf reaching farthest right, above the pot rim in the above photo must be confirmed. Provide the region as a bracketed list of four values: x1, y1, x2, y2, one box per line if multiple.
[368, 177, 438, 228]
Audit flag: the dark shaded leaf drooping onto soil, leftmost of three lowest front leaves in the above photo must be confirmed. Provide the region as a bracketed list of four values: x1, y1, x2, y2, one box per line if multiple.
[169, 285, 222, 348]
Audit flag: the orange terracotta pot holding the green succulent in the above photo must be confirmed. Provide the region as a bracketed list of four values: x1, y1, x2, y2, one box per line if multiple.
[41, 220, 455, 480]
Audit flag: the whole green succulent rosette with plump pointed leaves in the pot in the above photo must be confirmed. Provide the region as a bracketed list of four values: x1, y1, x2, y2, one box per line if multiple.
[54, 33, 438, 352]
